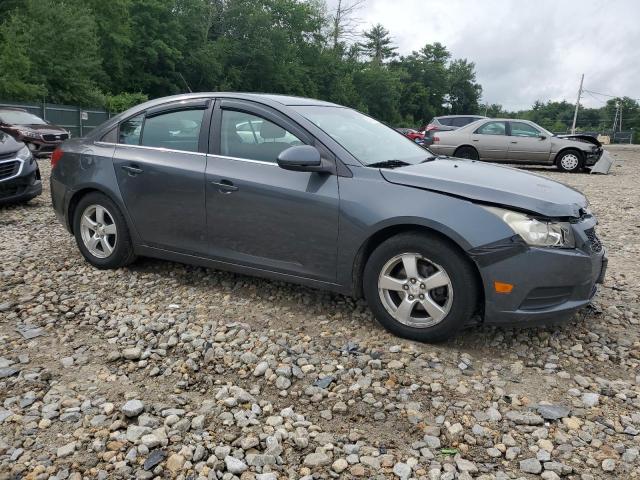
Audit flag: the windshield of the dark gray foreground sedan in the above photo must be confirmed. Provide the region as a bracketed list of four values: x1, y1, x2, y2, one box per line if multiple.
[292, 105, 432, 165]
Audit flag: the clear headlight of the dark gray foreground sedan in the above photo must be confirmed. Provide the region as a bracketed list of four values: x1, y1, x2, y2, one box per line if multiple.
[484, 207, 575, 248]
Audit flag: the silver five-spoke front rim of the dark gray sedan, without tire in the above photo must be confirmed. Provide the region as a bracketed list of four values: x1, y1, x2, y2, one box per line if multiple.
[378, 253, 453, 328]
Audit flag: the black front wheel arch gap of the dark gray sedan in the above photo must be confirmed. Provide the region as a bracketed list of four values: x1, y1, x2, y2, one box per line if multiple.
[352, 223, 485, 309]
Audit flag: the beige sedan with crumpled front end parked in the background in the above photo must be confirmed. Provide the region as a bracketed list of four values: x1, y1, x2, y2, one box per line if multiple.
[429, 118, 603, 172]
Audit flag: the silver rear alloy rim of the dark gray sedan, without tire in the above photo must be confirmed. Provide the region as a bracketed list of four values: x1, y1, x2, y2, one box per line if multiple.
[80, 205, 118, 258]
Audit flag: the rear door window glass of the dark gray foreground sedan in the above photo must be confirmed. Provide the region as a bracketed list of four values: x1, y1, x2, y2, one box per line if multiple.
[140, 109, 204, 152]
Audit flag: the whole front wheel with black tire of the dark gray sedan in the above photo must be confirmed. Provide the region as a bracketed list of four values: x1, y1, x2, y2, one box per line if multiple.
[363, 233, 478, 342]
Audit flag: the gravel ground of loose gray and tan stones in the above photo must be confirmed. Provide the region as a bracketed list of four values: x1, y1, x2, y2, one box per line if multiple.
[0, 149, 640, 480]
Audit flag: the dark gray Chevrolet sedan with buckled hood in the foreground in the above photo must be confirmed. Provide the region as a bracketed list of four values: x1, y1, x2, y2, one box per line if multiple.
[51, 93, 606, 341]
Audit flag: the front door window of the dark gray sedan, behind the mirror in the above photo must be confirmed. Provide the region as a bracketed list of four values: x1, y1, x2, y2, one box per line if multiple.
[220, 110, 304, 163]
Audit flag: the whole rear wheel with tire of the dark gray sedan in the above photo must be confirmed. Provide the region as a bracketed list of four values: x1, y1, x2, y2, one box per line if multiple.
[73, 192, 136, 269]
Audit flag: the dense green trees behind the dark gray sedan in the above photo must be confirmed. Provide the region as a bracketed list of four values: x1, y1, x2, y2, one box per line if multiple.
[0, 0, 481, 126]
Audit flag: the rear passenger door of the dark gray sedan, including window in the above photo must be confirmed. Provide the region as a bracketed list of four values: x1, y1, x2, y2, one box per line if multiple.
[113, 99, 212, 254]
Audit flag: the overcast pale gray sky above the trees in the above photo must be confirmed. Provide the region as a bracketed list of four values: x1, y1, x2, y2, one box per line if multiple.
[342, 0, 640, 110]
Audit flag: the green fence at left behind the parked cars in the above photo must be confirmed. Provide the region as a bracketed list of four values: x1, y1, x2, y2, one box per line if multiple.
[0, 100, 111, 137]
